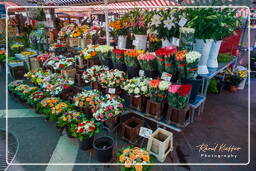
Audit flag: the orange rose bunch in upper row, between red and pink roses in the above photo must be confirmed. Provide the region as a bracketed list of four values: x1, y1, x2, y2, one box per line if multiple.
[124, 49, 144, 79]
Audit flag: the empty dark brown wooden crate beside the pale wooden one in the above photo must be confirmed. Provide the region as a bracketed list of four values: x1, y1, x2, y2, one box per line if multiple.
[121, 117, 143, 144]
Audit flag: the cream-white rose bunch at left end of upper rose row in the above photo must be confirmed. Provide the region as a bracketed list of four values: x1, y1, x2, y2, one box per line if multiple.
[95, 45, 113, 65]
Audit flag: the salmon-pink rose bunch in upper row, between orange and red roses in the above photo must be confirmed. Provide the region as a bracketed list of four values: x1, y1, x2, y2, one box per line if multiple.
[138, 53, 158, 78]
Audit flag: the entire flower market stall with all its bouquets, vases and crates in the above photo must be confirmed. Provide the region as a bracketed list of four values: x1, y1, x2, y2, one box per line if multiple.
[3, 1, 250, 171]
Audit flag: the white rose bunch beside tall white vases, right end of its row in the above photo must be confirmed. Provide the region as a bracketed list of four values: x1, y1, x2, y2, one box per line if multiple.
[186, 51, 201, 79]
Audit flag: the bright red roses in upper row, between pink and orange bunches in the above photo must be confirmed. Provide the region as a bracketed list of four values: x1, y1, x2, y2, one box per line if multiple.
[155, 46, 177, 74]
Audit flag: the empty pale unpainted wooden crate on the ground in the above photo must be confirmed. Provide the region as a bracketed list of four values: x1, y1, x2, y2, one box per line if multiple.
[147, 128, 173, 162]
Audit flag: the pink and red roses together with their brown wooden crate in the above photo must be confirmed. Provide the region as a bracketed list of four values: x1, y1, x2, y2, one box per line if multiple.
[165, 85, 192, 127]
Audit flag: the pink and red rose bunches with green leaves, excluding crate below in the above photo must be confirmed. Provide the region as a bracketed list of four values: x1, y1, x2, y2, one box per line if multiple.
[168, 84, 192, 109]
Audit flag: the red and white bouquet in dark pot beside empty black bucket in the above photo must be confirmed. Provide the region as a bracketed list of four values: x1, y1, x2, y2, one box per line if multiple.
[70, 119, 100, 150]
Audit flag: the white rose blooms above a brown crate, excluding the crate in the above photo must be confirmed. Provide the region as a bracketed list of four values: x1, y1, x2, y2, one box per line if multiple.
[123, 77, 150, 96]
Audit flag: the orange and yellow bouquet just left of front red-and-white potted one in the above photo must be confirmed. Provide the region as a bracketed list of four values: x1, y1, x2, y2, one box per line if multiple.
[57, 110, 85, 129]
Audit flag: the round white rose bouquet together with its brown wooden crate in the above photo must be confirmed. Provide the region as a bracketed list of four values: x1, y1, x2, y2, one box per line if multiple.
[123, 77, 150, 112]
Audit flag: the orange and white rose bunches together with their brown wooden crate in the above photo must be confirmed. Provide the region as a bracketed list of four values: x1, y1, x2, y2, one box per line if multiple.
[145, 80, 171, 120]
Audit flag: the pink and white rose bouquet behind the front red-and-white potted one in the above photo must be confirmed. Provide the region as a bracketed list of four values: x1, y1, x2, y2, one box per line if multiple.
[93, 96, 124, 121]
